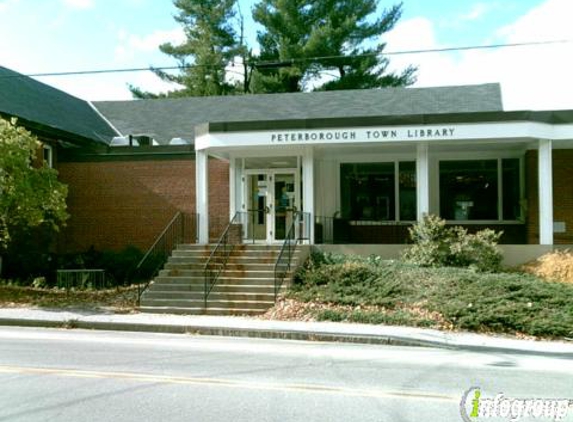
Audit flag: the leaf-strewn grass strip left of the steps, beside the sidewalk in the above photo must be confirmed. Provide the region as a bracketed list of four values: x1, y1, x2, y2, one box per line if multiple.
[0, 283, 137, 311]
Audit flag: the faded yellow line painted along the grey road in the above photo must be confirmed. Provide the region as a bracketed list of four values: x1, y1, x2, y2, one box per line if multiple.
[0, 365, 459, 402]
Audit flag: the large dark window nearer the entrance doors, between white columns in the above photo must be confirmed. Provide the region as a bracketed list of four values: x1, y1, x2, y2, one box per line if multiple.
[340, 162, 416, 221]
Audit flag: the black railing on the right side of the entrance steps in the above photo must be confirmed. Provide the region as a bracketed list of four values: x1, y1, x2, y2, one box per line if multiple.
[275, 212, 310, 301]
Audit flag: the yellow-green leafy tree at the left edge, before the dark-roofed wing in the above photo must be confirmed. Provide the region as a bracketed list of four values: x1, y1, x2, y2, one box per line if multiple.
[0, 118, 68, 251]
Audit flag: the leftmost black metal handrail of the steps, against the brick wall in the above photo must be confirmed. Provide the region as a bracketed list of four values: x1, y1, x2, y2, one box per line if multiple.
[134, 211, 199, 306]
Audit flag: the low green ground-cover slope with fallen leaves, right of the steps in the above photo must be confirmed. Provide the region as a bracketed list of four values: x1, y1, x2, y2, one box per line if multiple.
[288, 255, 573, 338]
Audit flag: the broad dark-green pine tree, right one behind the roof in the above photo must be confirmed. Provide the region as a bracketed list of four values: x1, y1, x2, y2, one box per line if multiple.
[253, 0, 416, 92]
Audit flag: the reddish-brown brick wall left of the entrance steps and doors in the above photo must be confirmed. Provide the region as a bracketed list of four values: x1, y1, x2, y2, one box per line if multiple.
[58, 157, 229, 252]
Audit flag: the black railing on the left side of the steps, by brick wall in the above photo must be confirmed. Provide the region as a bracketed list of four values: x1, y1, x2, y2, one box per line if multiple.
[134, 212, 199, 306]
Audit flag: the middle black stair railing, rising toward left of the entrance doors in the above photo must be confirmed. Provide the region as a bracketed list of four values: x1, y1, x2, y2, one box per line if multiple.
[203, 212, 243, 309]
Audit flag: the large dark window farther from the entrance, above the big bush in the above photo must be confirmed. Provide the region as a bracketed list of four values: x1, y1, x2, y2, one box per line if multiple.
[440, 158, 521, 221]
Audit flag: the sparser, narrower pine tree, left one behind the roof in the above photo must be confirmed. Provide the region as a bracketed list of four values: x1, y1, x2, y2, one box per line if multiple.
[130, 0, 240, 98]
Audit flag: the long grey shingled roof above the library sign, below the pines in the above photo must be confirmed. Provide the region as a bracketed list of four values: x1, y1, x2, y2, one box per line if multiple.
[94, 84, 503, 143]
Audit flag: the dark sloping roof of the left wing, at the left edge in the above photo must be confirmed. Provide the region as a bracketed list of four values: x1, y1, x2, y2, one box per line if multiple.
[0, 66, 117, 143]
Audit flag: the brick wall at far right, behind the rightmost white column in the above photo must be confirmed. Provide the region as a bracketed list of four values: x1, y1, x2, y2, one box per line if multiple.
[525, 149, 573, 245]
